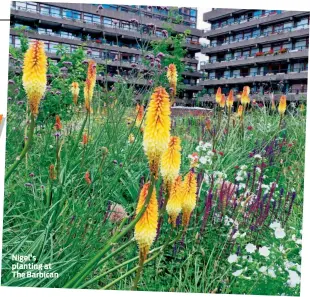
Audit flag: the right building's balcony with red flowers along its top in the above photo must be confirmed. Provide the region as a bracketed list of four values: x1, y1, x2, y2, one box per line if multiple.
[200, 47, 309, 70]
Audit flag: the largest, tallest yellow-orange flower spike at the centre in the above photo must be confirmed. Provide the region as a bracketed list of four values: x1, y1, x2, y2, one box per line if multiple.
[143, 87, 171, 177]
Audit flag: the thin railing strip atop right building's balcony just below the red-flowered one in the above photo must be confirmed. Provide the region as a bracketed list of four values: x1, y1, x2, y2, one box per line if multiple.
[206, 66, 308, 80]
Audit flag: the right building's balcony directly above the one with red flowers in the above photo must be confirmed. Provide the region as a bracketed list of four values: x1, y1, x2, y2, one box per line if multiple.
[201, 25, 309, 54]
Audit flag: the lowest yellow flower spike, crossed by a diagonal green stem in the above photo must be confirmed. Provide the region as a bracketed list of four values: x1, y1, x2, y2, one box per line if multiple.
[135, 182, 158, 262]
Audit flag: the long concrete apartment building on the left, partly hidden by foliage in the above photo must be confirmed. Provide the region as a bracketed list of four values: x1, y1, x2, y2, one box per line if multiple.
[10, 1, 203, 102]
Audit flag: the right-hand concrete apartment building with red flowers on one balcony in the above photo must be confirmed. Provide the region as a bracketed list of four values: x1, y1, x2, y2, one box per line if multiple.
[200, 9, 310, 98]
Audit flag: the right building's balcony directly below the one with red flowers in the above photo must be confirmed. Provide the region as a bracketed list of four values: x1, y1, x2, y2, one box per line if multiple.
[199, 69, 308, 86]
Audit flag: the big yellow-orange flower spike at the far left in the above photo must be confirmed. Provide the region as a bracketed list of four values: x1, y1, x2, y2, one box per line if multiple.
[23, 40, 47, 116]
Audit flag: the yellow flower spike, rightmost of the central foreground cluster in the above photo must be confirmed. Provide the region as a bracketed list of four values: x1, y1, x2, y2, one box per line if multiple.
[182, 171, 197, 228]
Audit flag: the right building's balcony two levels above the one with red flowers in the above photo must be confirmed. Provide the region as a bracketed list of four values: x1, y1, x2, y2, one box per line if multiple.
[204, 11, 309, 38]
